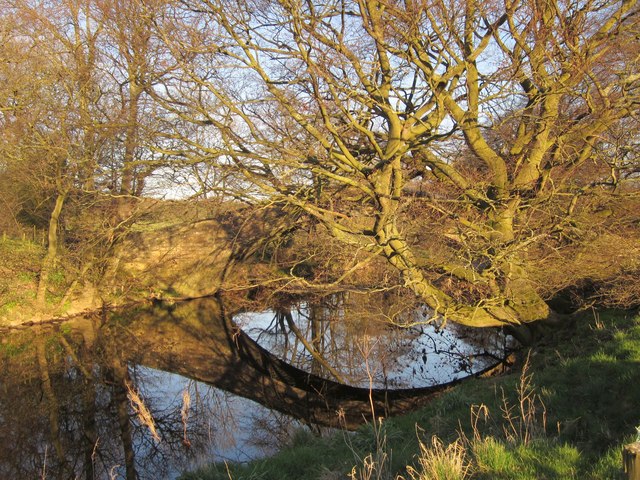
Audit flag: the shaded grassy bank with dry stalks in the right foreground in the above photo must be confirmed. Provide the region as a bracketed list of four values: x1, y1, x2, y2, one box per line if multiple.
[183, 312, 640, 480]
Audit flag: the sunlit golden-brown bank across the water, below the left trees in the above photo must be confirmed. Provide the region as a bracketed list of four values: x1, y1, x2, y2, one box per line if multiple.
[0, 203, 238, 327]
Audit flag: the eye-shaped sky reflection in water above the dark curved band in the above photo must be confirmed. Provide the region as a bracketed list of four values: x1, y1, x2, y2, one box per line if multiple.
[234, 293, 507, 389]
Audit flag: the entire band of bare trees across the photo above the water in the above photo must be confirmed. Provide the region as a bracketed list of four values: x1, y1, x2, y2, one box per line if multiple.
[0, 0, 640, 326]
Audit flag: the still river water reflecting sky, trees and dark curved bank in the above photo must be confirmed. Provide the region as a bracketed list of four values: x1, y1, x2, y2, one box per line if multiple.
[0, 297, 510, 479]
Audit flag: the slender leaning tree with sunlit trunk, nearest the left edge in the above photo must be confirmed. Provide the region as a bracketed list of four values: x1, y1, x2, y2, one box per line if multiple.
[3, 0, 104, 307]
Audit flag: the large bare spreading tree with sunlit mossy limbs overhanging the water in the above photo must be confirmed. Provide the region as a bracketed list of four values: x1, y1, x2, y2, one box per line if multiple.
[155, 0, 640, 326]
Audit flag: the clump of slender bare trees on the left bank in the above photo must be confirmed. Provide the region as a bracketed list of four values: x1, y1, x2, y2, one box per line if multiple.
[0, 0, 178, 307]
